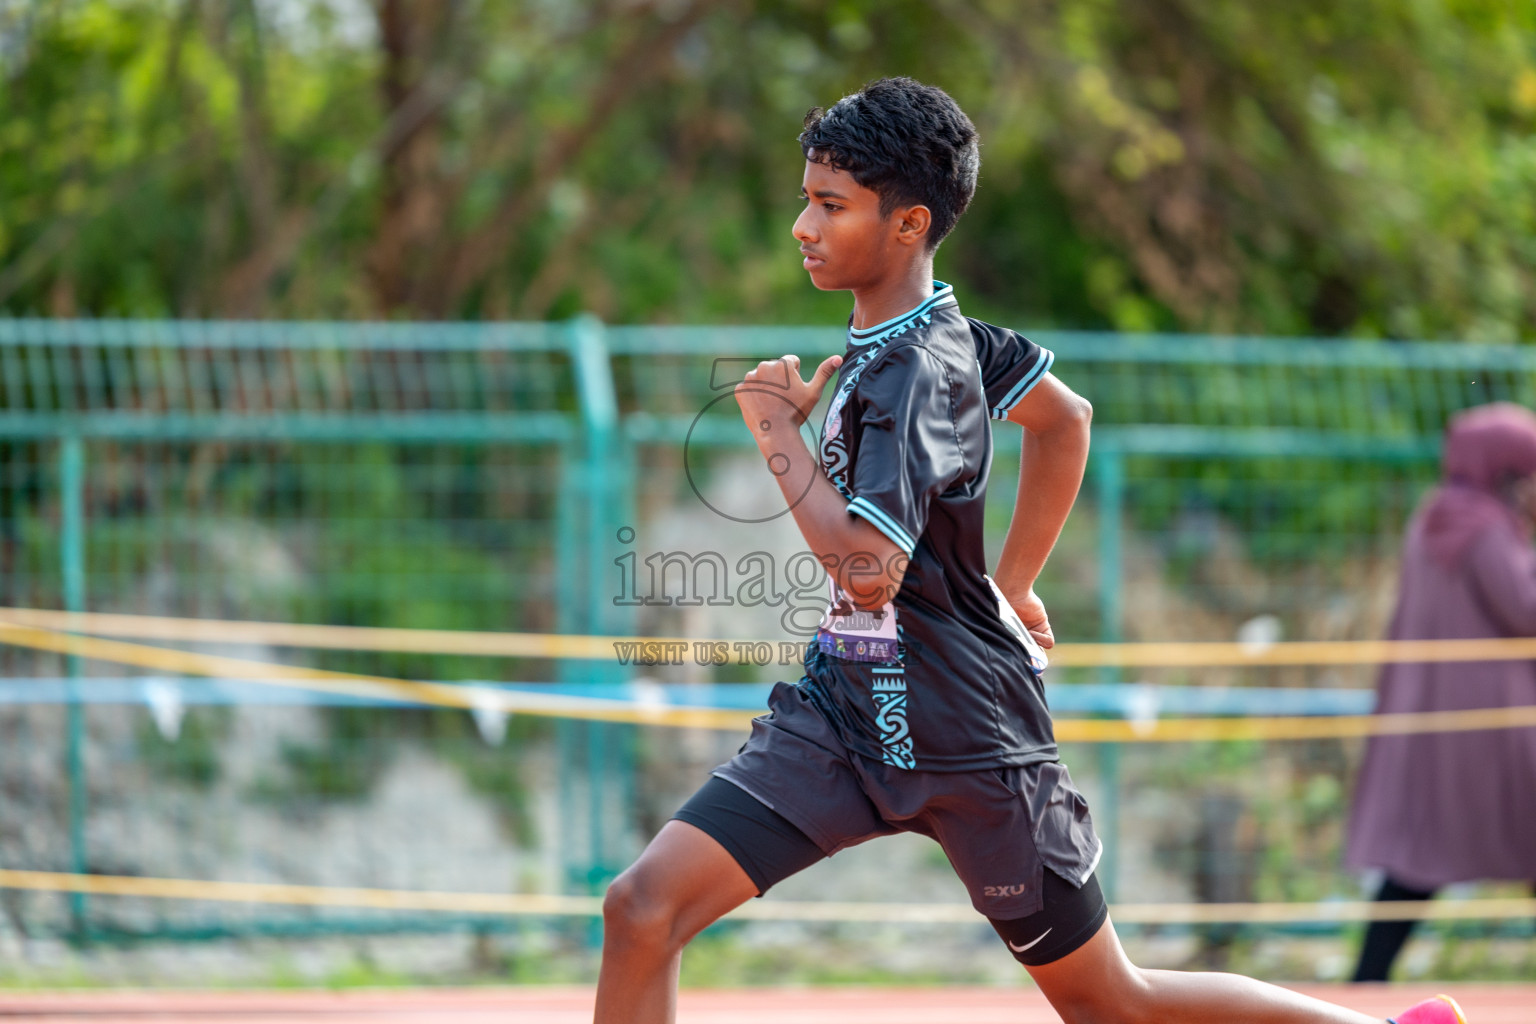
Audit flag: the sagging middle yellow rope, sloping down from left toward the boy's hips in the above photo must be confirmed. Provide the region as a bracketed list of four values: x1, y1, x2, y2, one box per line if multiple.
[0, 622, 1536, 743]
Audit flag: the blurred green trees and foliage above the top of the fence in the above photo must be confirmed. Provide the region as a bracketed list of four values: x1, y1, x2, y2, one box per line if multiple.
[0, 0, 1536, 341]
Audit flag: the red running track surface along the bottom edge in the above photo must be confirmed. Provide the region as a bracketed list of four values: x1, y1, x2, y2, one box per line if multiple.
[0, 984, 1536, 1024]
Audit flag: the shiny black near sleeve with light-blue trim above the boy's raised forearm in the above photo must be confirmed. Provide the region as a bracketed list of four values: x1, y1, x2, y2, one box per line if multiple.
[848, 345, 965, 554]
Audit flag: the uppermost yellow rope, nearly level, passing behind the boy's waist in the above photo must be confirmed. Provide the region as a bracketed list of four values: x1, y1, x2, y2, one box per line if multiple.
[0, 608, 1536, 668]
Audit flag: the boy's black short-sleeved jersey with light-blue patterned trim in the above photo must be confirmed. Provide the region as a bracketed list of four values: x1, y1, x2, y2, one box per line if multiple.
[802, 281, 1057, 771]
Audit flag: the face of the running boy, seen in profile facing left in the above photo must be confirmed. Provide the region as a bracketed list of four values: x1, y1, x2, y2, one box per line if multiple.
[794, 160, 928, 292]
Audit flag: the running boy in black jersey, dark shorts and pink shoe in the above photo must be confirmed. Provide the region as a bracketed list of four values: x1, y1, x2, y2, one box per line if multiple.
[596, 78, 1464, 1024]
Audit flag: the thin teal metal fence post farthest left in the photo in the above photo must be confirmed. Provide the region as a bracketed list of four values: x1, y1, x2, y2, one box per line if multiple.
[58, 438, 89, 938]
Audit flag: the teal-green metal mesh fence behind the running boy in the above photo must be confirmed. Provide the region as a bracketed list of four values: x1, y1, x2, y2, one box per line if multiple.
[0, 319, 1536, 936]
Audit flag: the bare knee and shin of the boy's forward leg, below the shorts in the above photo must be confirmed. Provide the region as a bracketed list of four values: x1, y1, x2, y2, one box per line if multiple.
[594, 820, 757, 1024]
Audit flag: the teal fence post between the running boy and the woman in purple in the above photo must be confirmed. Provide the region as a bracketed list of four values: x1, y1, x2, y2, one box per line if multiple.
[1094, 445, 1126, 901]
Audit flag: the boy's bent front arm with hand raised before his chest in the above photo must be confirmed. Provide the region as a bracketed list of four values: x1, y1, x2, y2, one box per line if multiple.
[736, 356, 906, 611]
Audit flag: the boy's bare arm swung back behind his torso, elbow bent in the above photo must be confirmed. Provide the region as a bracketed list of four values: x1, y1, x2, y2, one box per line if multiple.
[994, 373, 1094, 648]
